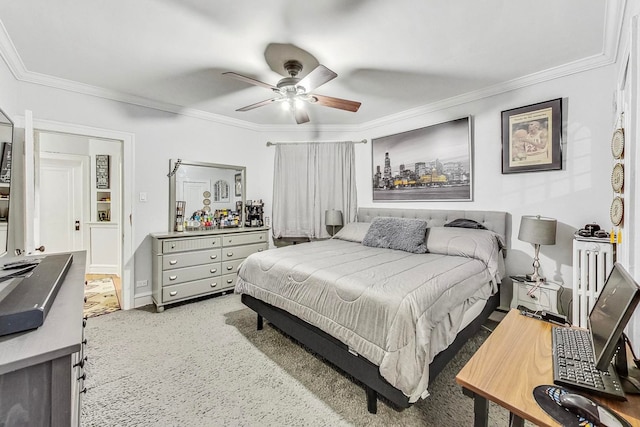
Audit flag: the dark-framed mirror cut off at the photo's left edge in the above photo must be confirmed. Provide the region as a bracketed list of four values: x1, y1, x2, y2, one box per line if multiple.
[0, 110, 13, 255]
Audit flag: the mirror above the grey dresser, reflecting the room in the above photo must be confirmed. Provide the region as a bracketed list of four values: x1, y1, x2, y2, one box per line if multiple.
[169, 159, 246, 231]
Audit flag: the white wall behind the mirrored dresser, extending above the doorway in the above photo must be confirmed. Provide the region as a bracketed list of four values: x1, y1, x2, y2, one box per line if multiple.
[0, 62, 272, 301]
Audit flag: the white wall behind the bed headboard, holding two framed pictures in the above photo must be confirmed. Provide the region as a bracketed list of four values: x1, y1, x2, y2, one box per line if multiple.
[348, 66, 616, 305]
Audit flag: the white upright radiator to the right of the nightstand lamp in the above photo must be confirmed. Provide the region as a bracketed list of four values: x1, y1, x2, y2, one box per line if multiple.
[572, 238, 616, 328]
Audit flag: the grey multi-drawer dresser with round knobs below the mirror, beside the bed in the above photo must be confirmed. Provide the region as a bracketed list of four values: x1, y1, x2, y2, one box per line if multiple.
[151, 227, 269, 312]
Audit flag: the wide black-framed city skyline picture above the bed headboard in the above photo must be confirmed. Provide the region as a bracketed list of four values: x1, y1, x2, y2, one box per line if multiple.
[371, 116, 473, 202]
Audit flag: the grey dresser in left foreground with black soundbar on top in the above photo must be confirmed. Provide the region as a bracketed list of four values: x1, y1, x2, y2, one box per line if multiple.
[0, 251, 86, 427]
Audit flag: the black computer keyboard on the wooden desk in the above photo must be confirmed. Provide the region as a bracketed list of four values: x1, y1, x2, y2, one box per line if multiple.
[551, 326, 627, 400]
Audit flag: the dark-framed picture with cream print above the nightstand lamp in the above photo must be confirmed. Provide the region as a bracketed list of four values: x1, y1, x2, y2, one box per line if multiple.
[502, 98, 562, 174]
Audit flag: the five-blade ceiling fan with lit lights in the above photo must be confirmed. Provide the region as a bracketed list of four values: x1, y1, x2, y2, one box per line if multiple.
[222, 60, 361, 124]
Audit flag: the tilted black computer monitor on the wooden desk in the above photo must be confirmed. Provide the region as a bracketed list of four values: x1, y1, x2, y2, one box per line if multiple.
[587, 263, 640, 371]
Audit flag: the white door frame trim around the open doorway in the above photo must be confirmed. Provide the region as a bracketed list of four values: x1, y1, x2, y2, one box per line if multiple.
[16, 115, 135, 310]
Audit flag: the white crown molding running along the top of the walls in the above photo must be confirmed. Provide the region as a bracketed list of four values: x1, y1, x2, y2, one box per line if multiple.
[0, 0, 627, 132]
